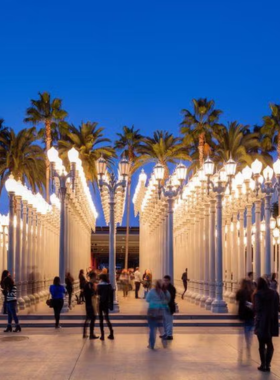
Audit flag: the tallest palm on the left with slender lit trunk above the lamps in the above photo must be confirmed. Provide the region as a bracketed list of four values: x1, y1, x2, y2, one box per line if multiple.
[24, 92, 68, 202]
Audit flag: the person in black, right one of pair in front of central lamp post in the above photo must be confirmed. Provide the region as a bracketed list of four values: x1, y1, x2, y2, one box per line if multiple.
[97, 273, 114, 340]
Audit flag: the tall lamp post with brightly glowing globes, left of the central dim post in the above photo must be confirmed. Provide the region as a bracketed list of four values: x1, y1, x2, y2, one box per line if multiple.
[48, 147, 79, 312]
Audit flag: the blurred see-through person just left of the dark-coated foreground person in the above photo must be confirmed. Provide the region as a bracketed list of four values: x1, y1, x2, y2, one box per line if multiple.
[236, 279, 254, 359]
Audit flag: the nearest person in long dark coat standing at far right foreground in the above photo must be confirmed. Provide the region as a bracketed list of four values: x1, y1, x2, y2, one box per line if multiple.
[253, 277, 279, 372]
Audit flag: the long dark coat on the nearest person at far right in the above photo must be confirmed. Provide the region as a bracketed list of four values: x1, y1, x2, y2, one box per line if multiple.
[254, 289, 279, 339]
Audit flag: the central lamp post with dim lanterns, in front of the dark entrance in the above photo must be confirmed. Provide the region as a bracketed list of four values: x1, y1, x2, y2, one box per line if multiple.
[96, 156, 130, 311]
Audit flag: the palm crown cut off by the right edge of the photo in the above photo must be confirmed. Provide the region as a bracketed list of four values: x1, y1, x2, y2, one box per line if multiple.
[261, 103, 280, 158]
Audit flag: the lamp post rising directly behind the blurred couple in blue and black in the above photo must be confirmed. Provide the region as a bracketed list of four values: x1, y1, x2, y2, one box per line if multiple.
[154, 163, 187, 281]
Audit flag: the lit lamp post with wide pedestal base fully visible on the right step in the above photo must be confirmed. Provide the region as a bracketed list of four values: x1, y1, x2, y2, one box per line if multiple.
[203, 158, 236, 313]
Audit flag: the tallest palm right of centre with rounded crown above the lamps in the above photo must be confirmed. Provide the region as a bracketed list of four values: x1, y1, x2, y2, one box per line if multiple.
[181, 98, 222, 166]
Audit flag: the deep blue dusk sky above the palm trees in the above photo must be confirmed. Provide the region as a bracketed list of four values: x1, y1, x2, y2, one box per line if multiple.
[0, 0, 280, 225]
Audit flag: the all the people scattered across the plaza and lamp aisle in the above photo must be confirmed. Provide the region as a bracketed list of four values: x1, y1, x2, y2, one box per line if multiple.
[1, 267, 279, 372]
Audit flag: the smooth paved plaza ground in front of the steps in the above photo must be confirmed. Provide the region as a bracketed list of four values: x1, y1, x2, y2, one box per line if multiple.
[0, 327, 280, 380]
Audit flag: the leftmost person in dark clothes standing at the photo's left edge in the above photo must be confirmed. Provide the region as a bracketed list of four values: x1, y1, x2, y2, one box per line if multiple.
[3, 276, 21, 332]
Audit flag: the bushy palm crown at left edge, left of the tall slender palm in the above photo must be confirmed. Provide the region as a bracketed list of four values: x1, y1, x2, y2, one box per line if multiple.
[0, 127, 46, 193]
